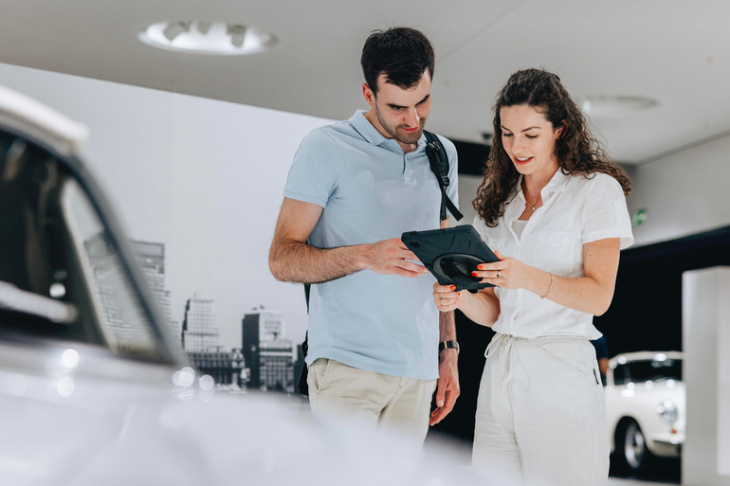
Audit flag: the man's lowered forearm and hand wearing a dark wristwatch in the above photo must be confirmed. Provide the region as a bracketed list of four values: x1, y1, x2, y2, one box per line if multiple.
[430, 218, 461, 425]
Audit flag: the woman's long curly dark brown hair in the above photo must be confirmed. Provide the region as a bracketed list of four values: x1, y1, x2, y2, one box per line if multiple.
[472, 69, 631, 228]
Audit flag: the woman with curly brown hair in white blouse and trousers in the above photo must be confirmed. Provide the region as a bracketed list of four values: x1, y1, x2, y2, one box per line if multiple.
[434, 69, 633, 486]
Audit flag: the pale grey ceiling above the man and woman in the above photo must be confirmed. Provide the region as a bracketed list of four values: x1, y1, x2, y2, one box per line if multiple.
[0, 0, 730, 165]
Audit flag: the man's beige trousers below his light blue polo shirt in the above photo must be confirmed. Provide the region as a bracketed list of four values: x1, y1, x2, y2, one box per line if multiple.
[307, 358, 436, 443]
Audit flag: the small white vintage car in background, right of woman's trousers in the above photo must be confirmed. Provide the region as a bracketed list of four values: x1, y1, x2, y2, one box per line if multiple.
[606, 351, 687, 472]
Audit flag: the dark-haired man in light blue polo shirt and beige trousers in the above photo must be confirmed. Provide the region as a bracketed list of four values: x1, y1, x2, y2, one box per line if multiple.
[269, 28, 459, 442]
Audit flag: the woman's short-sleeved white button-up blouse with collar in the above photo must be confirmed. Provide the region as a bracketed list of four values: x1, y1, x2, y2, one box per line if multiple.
[474, 170, 634, 339]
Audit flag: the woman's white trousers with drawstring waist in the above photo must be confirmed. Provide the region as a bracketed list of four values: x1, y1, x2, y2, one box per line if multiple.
[472, 334, 609, 486]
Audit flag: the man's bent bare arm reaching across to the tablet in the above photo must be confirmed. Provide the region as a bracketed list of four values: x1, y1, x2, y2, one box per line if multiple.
[269, 198, 427, 283]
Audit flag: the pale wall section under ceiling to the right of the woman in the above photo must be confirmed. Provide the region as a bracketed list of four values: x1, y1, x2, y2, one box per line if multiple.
[628, 136, 730, 246]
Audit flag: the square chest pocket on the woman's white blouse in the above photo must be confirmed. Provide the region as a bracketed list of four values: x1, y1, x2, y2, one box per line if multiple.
[533, 231, 583, 277]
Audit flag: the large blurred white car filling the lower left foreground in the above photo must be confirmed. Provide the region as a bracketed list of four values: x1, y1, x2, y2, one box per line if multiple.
[0, 87, 494, 486]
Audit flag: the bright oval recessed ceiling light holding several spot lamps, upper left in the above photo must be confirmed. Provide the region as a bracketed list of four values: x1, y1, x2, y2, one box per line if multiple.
[139, 20, 276, 56]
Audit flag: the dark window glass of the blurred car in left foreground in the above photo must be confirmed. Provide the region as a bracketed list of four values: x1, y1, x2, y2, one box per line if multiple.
[0, 129, 167, 361]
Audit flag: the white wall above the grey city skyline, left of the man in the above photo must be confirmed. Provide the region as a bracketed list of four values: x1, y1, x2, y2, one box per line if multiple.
[0, 64, 332, 347]
